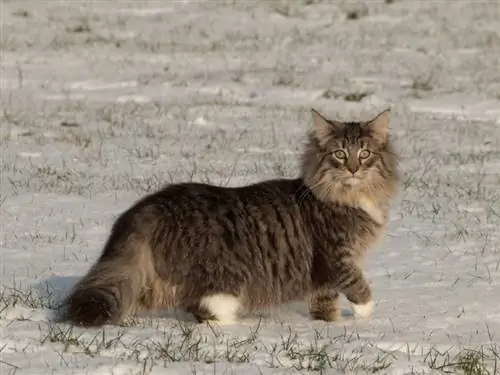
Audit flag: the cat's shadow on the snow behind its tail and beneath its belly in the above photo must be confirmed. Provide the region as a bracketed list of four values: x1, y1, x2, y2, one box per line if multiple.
[33, 276, 353, 322]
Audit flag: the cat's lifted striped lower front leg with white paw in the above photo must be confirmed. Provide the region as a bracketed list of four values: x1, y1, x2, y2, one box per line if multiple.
[338, 261, 373, 318]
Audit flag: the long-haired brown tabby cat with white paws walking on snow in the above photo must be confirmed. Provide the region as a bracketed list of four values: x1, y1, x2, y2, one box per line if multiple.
[64, 109, 399, 327]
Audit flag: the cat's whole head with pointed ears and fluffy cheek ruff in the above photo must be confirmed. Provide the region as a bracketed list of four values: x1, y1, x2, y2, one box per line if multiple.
[302, 109, 398, 203]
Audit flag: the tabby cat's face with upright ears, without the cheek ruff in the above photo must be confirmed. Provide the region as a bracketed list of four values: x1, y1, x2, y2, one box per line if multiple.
[304, 110, 392, 189]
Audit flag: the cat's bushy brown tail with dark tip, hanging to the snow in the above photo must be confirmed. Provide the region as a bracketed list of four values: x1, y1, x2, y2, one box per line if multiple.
[63, 236, 154, 327]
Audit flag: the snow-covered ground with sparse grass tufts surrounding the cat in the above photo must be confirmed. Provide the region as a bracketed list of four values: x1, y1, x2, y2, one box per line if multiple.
[0, 0, 500, 375]
